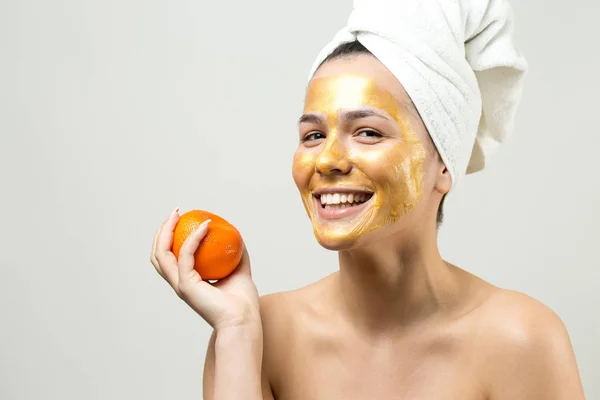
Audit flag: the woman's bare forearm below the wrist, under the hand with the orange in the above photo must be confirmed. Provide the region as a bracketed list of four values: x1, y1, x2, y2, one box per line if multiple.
[203, 326, 274, 400]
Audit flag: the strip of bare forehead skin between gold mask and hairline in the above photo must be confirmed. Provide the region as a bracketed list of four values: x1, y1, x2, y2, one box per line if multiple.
[308, 54, 412, 109]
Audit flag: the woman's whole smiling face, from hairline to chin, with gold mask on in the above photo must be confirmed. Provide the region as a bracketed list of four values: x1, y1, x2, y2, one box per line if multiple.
[293, 56, 442, 250]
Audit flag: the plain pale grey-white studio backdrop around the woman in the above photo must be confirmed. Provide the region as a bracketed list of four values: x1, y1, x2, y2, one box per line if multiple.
[0, 0, 600, 400]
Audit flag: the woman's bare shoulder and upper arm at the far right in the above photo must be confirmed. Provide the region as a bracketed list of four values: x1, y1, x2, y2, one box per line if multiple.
[474, 289, 584, 400]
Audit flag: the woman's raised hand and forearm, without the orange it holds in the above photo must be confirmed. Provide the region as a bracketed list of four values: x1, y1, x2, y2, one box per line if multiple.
[150, 209, 273, 400]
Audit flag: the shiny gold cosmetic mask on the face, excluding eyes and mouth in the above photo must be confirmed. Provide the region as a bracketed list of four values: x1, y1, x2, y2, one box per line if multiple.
[294, 75, 426, 245]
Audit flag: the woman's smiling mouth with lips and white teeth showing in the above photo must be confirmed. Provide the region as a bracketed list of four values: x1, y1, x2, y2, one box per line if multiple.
[313, 188, 373, 219]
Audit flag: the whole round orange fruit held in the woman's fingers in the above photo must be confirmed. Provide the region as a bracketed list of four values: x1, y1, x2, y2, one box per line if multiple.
[171, 210, 242, 280]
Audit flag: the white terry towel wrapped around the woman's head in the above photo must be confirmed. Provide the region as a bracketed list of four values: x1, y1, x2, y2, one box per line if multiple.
[310, 0, 527, 186]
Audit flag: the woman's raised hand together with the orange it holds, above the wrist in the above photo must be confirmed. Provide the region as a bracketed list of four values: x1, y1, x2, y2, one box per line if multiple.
[150, 208, 262, 331]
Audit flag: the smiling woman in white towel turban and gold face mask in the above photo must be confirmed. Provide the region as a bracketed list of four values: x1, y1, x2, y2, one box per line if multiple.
[152, 0, 584, 400]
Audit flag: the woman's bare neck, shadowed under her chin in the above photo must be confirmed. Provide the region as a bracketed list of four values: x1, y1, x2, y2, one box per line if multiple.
[336, 225, 458, 334]
